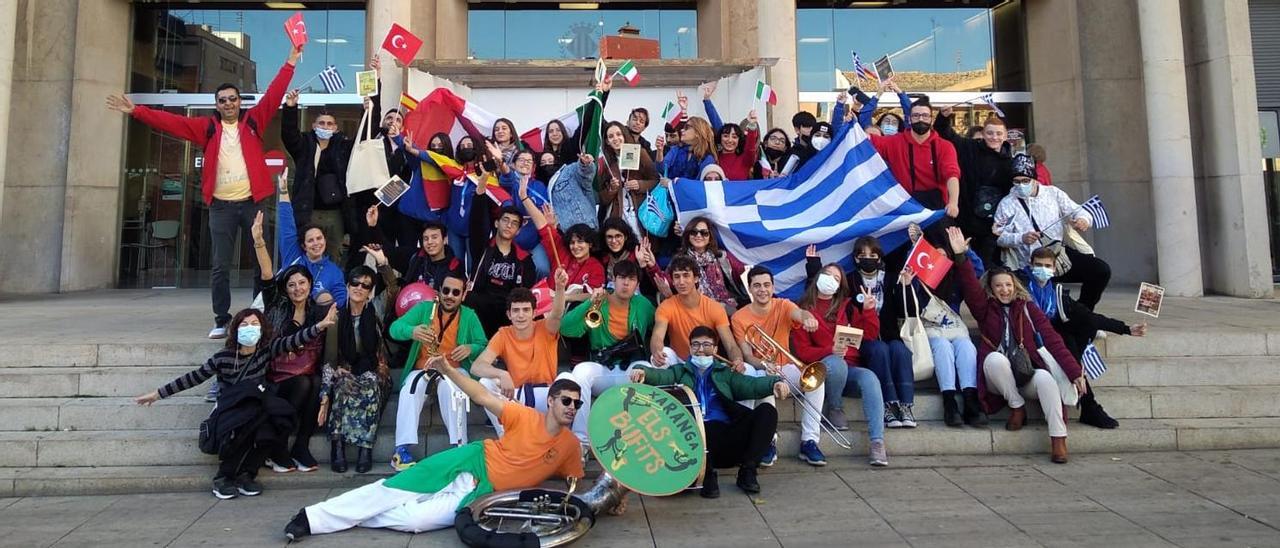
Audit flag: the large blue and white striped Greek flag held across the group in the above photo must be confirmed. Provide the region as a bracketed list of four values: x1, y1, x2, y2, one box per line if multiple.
[672, 124, 942, 298]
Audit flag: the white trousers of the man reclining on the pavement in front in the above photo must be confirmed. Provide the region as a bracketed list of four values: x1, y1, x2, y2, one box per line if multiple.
[305, 472, 476, 534]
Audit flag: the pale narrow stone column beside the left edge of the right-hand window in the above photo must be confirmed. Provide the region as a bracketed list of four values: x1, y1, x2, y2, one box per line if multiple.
[752, 0, 800, 133]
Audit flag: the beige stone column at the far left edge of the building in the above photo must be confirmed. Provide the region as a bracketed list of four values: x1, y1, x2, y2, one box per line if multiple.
[0, 0, 77, 293]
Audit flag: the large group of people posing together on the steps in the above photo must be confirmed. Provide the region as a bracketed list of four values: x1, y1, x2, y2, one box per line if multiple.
[115, 43, 1146, 538]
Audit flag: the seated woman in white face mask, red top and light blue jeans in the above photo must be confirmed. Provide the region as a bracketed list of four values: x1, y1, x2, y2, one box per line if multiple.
[791, 258, 888, 466]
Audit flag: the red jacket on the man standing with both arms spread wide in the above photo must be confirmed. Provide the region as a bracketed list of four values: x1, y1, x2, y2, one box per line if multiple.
[133, 63, 293, 204]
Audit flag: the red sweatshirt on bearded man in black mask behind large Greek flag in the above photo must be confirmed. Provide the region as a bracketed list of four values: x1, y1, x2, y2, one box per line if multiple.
[870, 128, 960, 205]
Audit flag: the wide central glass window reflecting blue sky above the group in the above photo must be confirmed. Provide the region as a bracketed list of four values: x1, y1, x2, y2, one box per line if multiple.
[467, 4, 698, 59]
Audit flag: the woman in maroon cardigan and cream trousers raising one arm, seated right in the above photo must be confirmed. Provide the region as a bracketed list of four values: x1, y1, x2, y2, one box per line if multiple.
[947, 227, 1088, 463]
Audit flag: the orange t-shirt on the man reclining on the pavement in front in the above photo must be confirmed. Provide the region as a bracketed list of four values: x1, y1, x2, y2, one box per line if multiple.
[484, 402, 582, 490]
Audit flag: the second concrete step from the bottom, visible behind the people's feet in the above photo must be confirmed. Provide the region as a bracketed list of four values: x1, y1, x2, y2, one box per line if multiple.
[10, 417, 1280, 467]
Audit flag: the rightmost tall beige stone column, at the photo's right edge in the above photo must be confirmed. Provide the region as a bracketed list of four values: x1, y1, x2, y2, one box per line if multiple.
[1183, 0, 1274, 298]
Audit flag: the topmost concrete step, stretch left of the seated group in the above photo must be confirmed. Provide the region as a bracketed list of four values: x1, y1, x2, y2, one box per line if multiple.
[0, 339, 223, 367]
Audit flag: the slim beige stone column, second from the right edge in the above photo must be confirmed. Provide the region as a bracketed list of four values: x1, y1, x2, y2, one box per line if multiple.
[1138, 0, 1204, 297]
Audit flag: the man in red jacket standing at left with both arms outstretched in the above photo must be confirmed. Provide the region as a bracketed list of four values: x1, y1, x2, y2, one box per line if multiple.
[106, 46, 302, 339]
